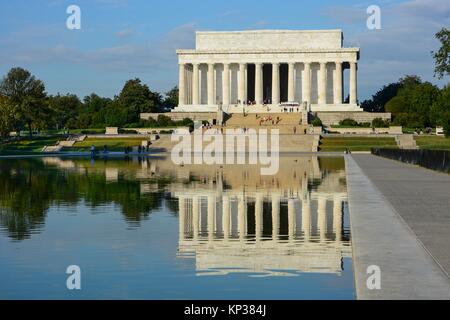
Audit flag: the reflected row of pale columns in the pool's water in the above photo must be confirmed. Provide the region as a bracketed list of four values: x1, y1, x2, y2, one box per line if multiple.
[179, 195, 342, 242]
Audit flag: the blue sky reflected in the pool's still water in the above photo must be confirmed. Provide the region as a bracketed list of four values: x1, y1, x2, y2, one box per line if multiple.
[0, 159, 354, 299]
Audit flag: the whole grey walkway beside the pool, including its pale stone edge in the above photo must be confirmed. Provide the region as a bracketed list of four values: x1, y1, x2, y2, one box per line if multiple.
[346, 154, 450, 299]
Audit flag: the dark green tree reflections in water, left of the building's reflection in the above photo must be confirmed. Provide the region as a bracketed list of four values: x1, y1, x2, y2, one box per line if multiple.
[0, 159, 169, 240]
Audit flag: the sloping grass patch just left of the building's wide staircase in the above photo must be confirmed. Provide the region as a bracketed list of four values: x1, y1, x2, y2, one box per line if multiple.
[71, 137, 146, 151]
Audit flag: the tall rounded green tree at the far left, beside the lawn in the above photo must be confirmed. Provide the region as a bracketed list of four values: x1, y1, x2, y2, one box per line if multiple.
[0, 68, 47, 136]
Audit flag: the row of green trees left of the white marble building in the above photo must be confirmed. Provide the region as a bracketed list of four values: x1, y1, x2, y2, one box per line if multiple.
[0, 67, 178, 137]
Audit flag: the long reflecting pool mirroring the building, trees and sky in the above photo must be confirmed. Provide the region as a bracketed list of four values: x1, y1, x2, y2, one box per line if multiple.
[0, 156, 355, 299]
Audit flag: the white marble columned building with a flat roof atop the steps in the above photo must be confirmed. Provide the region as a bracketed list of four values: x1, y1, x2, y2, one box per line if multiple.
[173, 30, 362, 113]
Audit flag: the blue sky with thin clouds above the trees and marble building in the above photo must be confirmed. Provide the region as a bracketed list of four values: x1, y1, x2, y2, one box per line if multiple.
[0, 0, 450, 100]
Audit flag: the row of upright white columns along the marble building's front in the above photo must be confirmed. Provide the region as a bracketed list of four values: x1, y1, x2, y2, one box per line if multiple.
[179, 62, 357, 105]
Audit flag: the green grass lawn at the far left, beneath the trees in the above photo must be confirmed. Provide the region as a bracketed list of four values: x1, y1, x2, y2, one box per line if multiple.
[0, 136, 61, 155]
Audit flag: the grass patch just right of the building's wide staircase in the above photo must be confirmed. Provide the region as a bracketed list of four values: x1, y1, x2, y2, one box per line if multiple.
[319, 137, 398, 151]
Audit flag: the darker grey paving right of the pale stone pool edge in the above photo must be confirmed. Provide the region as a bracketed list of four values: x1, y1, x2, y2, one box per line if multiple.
[353, 155, 450, 275]
